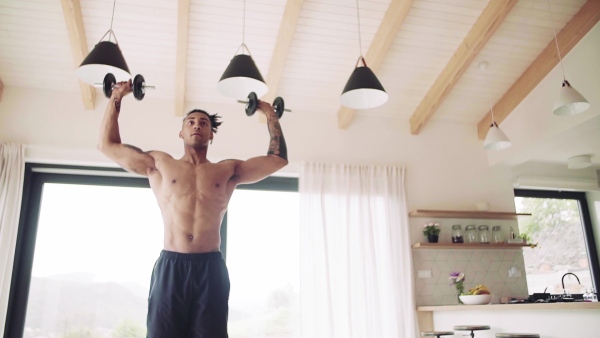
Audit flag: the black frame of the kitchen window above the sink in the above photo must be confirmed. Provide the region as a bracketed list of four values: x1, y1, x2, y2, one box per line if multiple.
[514, 189, 600, 290]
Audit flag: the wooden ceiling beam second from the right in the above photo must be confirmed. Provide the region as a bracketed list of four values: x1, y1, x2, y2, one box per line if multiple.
[410, 0, 517, 135]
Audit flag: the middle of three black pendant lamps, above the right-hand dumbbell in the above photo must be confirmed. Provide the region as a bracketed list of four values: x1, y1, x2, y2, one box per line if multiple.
[217, 0, 269, 100]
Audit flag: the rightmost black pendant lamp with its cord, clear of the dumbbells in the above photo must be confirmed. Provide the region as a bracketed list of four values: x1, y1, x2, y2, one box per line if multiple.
[340, 0, 388, 109]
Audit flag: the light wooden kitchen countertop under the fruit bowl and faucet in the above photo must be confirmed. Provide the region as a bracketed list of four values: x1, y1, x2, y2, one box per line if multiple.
[417, 302, 600, 331]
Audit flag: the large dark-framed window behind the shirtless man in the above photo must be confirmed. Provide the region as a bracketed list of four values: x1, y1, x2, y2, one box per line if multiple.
[4, 165, 299, 338]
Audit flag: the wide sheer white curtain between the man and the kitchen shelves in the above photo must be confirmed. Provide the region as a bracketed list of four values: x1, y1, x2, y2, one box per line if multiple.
[299, 163, 416, 338]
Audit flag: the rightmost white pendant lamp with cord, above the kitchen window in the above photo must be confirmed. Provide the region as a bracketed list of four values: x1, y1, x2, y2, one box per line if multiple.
[548, 0, 590, 116]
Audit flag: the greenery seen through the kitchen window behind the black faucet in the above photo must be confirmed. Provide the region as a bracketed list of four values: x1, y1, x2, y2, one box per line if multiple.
[515, 197, 592, 294]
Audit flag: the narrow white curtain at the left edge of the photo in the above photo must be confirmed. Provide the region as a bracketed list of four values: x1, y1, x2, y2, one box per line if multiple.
[0, 144, 25, 334]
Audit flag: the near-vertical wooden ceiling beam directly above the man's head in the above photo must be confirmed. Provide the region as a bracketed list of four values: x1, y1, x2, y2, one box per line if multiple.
[175, 0, 190, 116]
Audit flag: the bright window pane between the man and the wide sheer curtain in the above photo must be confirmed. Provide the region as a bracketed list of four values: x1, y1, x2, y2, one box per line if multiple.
[227, 190, 300, 338]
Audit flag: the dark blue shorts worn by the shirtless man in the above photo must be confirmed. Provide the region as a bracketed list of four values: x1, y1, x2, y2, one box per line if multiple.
[147, 250, 230, 338]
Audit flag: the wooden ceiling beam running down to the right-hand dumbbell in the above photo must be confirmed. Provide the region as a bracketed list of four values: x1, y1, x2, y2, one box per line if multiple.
[258, 0, 304, 123]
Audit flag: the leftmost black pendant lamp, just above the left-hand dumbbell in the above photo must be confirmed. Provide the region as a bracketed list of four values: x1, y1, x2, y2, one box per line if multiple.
[75, 0, 131, 85]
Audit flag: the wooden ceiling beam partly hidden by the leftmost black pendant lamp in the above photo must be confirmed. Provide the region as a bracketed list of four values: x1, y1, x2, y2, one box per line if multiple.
[61, 0, 96, 110]
